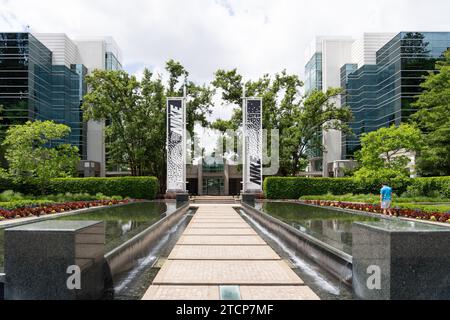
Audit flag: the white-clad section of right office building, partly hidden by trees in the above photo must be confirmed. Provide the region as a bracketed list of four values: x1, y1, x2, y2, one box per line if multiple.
[305, 33, 418, 177]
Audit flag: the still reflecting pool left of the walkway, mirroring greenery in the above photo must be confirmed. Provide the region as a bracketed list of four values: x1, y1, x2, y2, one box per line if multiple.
[0, 202, 176, 272]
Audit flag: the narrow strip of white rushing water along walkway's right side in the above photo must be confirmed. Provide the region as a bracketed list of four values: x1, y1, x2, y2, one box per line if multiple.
[240, 210, 340, 296]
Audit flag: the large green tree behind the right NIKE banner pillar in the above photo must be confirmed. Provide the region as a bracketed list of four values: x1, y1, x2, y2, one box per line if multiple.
[213, 69, 352, 175]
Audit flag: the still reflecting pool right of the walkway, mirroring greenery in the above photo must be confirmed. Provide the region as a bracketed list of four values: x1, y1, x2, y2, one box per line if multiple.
[255, 202, 380, 255]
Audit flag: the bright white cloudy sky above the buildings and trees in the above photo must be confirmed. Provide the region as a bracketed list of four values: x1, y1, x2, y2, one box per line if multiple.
[0, 0, 450, 119]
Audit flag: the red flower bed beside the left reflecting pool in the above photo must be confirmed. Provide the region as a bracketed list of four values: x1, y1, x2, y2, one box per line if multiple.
[0, 200, 132, 219]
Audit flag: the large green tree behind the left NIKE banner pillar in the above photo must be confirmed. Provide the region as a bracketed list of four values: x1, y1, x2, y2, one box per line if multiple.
[82, 60, 213, 191]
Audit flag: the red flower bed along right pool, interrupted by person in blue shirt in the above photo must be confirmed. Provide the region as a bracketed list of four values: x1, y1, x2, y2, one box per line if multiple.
[304, 200, 450, 223]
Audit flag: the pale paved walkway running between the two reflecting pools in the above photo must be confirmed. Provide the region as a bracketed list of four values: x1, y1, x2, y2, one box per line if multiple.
[143, 204, 319, 300]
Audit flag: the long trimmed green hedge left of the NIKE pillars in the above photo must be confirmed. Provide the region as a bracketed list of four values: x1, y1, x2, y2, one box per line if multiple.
[0, 177, 159, 200]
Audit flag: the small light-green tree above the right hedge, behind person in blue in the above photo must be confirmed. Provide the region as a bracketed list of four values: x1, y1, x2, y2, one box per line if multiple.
[355, 124, 422, 181]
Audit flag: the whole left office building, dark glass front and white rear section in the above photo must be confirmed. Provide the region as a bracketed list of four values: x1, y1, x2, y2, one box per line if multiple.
[0, 32, 121, 176]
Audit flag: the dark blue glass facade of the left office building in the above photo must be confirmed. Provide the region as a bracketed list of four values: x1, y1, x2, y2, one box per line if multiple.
[0, 33, 86, 159]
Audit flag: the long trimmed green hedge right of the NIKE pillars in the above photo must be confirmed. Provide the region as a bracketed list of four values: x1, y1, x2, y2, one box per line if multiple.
[264, 177, 450, 199]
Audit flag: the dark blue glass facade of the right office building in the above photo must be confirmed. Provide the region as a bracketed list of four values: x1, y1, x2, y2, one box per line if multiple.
[341, 32, 450, 159]
